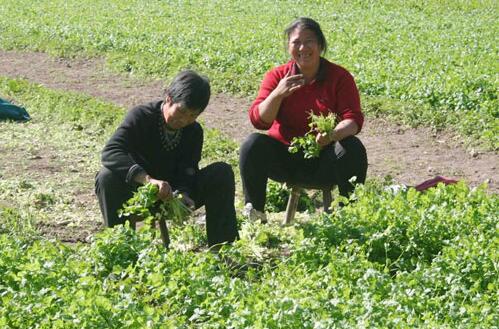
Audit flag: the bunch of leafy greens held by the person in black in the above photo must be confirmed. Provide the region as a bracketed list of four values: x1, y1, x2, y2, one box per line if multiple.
[120, 183, 191, 224]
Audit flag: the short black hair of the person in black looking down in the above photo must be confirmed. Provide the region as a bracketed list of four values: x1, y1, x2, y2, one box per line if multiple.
[165, 70, 211, 113]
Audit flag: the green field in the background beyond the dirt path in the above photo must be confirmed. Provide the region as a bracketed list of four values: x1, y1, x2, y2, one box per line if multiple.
[0, 0, 499, 149]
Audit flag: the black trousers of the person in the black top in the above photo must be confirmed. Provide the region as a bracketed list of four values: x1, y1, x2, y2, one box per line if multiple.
[95, 162, 238, 246]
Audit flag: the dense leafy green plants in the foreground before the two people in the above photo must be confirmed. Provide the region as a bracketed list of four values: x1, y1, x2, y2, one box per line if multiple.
[0, 184, 499, 328]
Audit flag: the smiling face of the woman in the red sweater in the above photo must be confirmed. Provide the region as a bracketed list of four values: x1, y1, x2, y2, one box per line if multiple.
[288, 28, 322, 70]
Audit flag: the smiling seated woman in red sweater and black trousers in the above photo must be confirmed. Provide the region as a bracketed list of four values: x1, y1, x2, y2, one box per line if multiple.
[239, 17, 367, 221]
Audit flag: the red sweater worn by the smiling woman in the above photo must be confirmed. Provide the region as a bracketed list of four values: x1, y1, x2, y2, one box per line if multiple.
[249, 58, 364, 145]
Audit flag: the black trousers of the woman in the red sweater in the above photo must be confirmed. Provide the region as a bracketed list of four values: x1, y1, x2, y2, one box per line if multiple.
[239, 133, 367, 211]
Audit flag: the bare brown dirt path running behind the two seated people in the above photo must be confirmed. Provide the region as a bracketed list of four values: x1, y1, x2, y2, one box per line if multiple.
[0, 51, 499, 193]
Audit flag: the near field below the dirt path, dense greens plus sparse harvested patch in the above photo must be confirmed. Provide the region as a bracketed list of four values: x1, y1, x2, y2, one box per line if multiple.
[0, 79, 499, 328]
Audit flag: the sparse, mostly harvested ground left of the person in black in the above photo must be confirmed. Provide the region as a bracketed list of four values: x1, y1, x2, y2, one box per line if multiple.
[0, 77, 125, 231]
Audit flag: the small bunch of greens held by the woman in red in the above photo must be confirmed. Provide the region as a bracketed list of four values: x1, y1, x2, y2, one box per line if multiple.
[288, 110, 336, 159]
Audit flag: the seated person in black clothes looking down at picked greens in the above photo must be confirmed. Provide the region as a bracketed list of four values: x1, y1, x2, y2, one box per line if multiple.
[95, 70, 238, 245]
